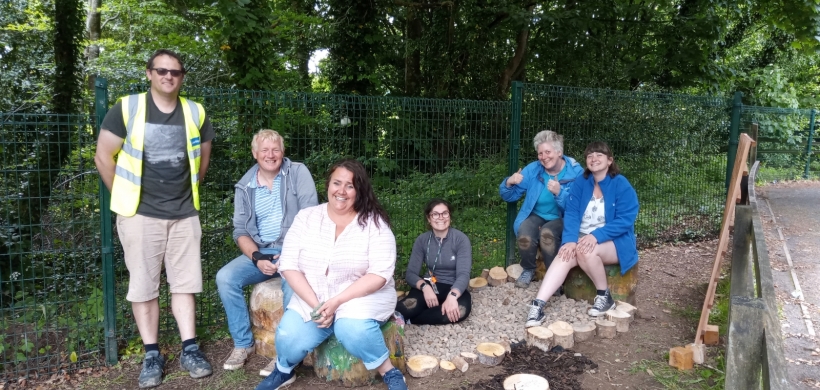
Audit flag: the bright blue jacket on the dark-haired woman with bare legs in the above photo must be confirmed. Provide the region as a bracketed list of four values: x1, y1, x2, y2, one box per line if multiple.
[561, 175, 639, 274]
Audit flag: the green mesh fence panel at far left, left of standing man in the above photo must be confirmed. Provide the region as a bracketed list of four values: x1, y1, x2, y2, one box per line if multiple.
[0, 113, 104, 382]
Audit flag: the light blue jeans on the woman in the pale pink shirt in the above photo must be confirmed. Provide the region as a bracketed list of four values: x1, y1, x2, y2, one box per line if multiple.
[276, 310, 390, 374]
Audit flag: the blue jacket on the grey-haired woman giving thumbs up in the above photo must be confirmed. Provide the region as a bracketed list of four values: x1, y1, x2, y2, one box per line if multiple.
[498, 156, 584, 236]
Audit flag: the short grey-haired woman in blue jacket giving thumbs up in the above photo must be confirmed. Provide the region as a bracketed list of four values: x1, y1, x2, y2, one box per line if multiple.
[498, 130, 584, 288]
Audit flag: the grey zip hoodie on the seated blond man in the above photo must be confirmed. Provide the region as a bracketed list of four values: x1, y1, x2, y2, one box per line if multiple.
[233, 157, 319, 248]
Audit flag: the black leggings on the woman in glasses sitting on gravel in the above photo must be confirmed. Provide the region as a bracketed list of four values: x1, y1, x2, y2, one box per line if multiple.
[396, 283, 473, 325]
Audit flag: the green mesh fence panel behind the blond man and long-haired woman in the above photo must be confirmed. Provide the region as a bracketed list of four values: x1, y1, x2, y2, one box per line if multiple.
[109, 89, 509, 337]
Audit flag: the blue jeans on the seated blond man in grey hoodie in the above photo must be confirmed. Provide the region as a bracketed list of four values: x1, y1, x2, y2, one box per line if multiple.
[216, 248, 293, 348]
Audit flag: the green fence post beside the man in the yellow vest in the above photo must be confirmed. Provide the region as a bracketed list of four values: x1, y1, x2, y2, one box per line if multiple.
[94, 77, 118, 365]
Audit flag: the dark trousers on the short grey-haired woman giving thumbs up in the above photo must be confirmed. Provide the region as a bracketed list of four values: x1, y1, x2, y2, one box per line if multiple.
[518, 213, 564, 270]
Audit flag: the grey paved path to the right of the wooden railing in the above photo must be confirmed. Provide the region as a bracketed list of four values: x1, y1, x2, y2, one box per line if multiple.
[758, 182, 820, 389]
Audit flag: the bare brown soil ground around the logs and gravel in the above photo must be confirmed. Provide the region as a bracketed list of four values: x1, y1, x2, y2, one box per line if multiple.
[0, 239, 724, 390]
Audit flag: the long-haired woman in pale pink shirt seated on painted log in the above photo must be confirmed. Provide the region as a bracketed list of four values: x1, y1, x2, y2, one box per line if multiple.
[257, 160, 407, 390]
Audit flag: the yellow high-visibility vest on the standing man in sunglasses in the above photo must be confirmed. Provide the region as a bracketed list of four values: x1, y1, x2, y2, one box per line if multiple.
[111, 93, 205, 217]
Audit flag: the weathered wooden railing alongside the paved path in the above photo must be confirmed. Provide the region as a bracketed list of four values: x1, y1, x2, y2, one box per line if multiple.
[725, 162, 792, 390]
